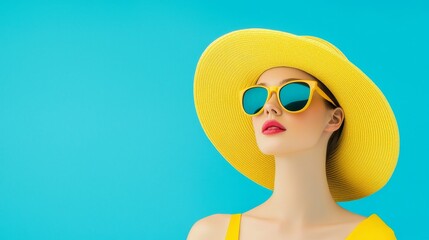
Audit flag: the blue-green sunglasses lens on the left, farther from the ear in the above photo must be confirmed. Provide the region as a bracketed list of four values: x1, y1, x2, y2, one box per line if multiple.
[242, 87, 268, 114]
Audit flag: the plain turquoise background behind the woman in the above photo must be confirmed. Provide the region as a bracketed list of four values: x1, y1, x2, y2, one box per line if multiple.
[0, 0, 429, 239]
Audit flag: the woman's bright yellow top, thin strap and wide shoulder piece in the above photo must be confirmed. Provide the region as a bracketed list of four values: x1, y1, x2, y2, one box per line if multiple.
[225, 213, 396, 240]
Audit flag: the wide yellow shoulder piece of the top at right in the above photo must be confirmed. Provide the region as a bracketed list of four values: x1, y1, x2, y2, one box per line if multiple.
[351, 214, 396, 240]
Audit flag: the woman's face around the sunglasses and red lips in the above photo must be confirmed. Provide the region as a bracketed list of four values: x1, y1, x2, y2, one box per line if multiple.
[252, 67, 332, 156]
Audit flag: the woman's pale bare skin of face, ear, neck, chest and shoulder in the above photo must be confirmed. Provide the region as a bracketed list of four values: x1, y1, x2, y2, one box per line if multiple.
[187, 67, 366, 240]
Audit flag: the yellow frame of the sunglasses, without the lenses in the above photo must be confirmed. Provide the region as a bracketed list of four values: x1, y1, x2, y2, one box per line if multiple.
[240, 79, 337, 116]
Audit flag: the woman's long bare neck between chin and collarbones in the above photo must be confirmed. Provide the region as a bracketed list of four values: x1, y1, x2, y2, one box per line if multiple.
[264, 141, 340, 224]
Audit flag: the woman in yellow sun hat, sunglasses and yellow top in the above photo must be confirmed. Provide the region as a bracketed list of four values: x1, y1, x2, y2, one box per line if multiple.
[188, 29, 399, 240]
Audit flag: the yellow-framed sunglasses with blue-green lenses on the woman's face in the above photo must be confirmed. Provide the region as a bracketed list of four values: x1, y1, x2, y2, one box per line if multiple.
[240, 80, 336, 116]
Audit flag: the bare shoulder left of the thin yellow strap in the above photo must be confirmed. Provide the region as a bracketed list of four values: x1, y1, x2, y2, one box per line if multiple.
[186, 213, 231, 240]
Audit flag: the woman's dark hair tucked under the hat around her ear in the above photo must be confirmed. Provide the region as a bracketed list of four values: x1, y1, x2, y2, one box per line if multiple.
[316, 78, 346, 161]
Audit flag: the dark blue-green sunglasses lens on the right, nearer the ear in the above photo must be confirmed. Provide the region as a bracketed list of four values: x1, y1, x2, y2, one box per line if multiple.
[279, 82, 310, 111]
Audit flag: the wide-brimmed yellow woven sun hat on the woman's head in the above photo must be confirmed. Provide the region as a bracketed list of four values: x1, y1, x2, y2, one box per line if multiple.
[194, 28, 399, 202]
